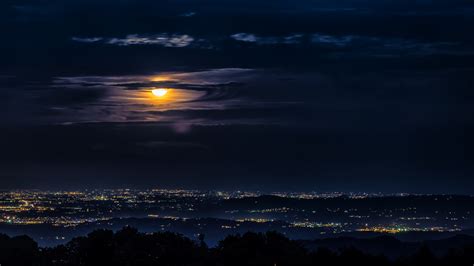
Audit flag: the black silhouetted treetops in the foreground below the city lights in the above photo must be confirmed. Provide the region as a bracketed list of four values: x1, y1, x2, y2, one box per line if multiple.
[0, 227, 474, 266]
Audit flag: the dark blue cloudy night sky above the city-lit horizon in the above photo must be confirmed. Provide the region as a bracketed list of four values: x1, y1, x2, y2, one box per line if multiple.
[0, 0, 474, 194]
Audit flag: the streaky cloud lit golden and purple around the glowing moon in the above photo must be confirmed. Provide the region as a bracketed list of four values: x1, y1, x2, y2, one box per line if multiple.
[42, 68, 265, 124]
